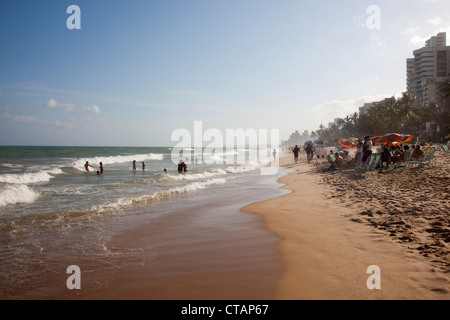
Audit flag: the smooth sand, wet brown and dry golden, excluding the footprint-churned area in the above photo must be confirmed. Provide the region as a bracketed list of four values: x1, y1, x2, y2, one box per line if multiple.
[60, 154, 450, 300]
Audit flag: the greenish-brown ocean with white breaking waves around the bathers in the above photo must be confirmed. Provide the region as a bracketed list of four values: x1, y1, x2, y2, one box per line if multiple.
[0, 146, 285, 299]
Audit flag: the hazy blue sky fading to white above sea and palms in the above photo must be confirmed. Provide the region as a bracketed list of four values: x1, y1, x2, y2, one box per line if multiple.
[0, 0, 450, 146]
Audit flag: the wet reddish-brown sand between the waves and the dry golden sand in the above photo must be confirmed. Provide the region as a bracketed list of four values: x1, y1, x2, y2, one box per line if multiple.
[77, 165, 285, 300]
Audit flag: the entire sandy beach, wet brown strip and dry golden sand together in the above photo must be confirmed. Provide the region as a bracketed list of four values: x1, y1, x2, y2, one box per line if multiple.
[78, 149, 450, 300]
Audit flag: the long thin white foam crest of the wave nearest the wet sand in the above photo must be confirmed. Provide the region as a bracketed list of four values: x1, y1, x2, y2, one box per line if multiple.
[92, 179, 226, 213]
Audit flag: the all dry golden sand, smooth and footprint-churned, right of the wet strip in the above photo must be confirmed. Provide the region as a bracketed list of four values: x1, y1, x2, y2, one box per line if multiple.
[244, 153, 450, 300]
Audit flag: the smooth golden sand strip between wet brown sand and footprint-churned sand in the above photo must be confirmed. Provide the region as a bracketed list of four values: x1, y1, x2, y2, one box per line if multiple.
[243, 151, 450, 300]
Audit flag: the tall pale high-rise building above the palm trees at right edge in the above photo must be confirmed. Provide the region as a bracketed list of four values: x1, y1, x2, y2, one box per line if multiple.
[406, 32, 450, 107]
